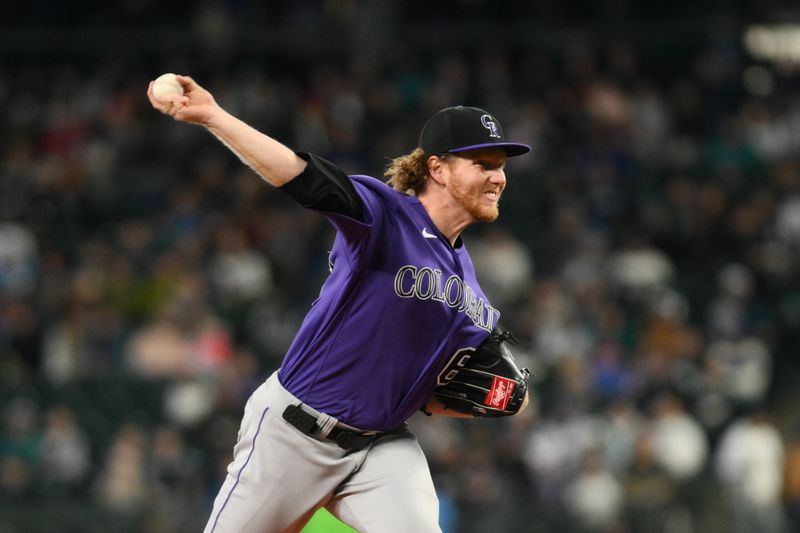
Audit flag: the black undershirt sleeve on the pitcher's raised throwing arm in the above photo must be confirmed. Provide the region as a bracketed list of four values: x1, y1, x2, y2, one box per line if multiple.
[280, 152, 364, 221]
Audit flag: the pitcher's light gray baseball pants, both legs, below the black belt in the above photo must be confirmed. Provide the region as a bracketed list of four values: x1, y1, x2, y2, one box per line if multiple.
[200, 373, 441, 533]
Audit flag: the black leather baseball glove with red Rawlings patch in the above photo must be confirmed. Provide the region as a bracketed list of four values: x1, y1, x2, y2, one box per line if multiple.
[433, 327, 530, 418]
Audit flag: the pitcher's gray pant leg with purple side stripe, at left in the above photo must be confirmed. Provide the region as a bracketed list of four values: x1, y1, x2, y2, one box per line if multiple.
[205, 375, 366, 533]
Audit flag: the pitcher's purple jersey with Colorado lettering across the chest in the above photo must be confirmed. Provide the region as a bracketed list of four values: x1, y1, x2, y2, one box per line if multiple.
[279, 176, 500, 430]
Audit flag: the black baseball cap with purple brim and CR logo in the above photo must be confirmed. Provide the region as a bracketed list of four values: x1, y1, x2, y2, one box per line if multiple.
[419, 106, 531, 157]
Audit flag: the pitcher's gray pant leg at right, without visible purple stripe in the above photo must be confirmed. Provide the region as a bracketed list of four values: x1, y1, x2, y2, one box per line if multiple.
[327, 431, 441, 533]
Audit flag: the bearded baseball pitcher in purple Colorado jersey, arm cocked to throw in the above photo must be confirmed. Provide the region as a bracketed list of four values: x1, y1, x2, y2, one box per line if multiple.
[147, 76, 530, 533]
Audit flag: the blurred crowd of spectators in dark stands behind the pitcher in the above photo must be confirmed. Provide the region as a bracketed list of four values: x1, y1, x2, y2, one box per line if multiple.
[0, 0, 800, 533]
